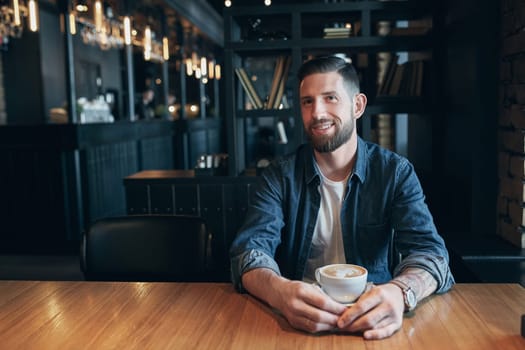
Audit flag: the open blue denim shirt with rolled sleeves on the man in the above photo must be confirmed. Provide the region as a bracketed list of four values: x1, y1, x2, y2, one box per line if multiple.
[230, 138, 454, 293]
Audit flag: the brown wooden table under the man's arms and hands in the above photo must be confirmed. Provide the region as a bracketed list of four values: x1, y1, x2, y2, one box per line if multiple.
[0, 281, 525, 350]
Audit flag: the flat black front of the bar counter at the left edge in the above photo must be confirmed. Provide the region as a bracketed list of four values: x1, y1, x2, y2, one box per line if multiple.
[0, 150, 65, 252]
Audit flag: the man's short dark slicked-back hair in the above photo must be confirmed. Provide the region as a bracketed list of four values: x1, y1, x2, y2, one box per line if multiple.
[297, 56, 359, 96]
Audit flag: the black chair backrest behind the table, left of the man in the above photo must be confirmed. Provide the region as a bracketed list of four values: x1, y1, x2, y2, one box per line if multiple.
[80, 215, 211, 281]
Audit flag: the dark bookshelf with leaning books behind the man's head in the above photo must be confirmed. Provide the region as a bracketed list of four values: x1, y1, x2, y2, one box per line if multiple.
[224, 0, 439, 175]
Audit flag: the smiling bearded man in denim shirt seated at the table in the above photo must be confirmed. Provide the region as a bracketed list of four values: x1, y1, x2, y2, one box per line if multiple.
[230, 56, 454, 339]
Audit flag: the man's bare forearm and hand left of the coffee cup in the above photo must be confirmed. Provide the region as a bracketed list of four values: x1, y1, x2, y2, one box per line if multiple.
[242, 268, 346, 333]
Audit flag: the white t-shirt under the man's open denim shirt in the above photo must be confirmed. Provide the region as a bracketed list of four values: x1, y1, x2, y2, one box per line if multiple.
[303, 166, 350, 282]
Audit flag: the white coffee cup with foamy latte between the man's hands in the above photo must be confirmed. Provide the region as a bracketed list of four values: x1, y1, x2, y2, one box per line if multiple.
[315, 264, 368, 304]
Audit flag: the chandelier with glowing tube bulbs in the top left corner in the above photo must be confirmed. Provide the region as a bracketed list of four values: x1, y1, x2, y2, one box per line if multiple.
[0, 0, 38, 38]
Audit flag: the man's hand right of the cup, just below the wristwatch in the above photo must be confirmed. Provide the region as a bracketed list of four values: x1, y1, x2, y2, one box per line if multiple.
[337, 283, 405, 339]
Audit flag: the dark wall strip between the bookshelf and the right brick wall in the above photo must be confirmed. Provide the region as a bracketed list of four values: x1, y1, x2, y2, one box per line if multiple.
[436, 0, 499, 235]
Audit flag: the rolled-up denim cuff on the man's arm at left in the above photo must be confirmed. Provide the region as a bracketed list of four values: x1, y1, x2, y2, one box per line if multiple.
[231, 249, 281, 292]
